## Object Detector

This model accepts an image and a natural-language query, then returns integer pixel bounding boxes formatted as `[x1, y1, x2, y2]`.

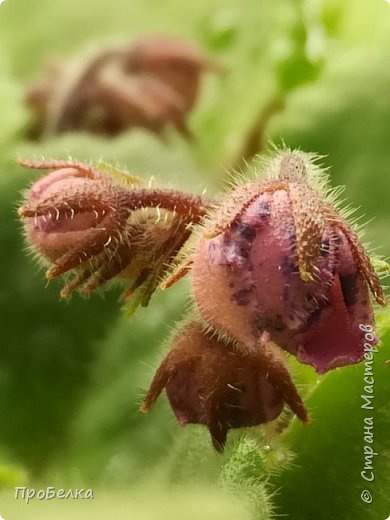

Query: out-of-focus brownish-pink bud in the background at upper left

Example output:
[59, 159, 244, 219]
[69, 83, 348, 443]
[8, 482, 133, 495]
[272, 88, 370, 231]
[26, 36, 217, 137]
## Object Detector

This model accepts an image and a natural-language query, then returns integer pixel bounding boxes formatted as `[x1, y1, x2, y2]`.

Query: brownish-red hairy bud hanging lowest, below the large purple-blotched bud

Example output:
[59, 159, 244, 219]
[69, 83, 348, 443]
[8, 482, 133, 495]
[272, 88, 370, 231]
[141, 321, 307, 451]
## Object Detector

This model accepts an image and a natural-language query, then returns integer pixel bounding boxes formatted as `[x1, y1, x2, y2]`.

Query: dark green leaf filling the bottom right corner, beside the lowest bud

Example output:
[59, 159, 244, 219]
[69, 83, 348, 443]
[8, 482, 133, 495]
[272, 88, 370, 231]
[274, 313, 390, 520]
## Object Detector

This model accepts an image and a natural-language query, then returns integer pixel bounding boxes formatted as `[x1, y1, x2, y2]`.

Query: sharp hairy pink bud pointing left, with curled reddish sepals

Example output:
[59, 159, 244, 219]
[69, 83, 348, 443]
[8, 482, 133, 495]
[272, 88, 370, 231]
[19, 161, 206, 309]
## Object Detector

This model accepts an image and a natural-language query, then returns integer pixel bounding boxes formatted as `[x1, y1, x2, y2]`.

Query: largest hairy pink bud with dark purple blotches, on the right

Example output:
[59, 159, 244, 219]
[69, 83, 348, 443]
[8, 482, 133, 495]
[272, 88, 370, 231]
[192, 151, 385, 372]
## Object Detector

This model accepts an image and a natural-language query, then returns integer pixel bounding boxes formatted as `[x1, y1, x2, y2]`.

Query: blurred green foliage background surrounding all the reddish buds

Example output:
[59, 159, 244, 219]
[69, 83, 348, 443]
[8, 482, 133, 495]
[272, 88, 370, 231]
[0, 0, 390, 520]
